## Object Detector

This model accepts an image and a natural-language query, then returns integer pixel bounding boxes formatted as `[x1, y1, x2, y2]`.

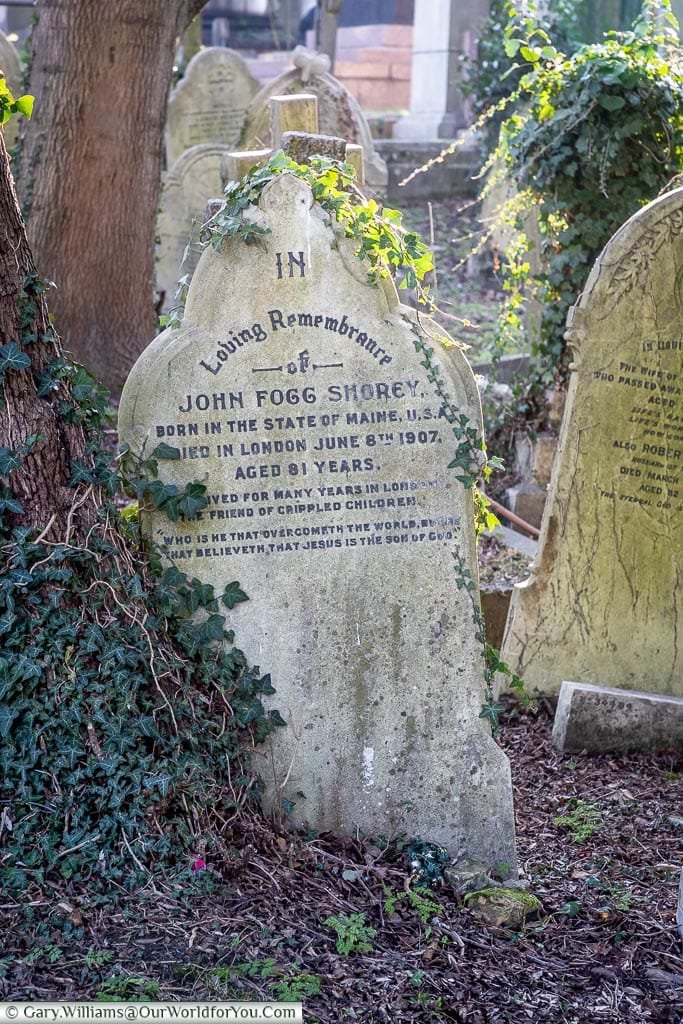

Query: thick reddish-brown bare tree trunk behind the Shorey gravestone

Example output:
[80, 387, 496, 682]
[19, 0, 205, 389]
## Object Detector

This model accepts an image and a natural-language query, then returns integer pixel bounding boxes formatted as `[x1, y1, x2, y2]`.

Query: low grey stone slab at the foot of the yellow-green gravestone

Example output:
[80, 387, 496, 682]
[553, 681, 683, 754]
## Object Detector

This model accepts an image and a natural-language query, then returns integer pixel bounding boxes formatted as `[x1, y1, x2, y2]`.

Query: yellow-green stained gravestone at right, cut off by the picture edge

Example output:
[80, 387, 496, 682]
[503, 189, 683, 695]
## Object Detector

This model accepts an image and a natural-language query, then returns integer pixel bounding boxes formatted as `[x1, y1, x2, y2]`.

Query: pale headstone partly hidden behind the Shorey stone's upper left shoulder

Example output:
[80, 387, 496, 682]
[157, 145, 226, 309]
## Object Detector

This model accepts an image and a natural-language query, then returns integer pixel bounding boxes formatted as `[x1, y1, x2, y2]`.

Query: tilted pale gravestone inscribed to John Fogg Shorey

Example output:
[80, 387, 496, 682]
[120, 167, 515, 870]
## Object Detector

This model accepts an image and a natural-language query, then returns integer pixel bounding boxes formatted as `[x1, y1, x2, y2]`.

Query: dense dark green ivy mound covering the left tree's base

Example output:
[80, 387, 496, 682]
[0, 274, 284, 905]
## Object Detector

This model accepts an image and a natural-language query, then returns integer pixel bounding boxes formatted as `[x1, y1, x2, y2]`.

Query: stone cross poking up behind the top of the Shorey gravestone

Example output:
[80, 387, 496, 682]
[221, 92, 365, 186]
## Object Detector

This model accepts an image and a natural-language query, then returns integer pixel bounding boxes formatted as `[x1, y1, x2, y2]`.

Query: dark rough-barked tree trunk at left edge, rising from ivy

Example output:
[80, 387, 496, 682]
[0, 126, 99, 543]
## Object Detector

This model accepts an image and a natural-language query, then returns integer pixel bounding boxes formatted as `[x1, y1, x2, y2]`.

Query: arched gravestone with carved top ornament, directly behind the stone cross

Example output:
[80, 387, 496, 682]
[240, 68, 388, 191]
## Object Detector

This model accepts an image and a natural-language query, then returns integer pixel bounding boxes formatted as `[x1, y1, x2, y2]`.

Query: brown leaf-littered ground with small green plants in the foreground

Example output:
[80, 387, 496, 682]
[0, 703, 683, 1024]
